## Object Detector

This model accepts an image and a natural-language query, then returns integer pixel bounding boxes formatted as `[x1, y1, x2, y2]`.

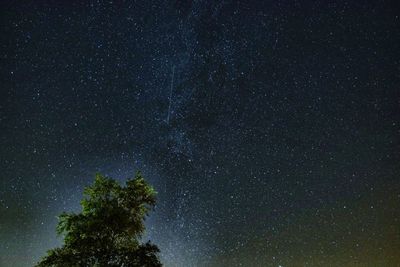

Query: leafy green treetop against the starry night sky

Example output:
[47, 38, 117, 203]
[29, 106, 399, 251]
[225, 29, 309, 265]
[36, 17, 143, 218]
[36, 172, 162, 267]
